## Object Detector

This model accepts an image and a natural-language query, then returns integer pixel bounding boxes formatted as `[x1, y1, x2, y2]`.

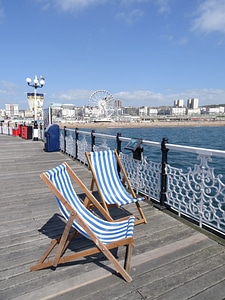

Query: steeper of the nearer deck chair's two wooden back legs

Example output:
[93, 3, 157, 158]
[52, 212, 75, 268]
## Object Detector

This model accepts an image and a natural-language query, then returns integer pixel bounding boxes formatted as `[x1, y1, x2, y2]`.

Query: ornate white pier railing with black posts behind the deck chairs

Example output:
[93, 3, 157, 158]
[60, 128, 225, 234]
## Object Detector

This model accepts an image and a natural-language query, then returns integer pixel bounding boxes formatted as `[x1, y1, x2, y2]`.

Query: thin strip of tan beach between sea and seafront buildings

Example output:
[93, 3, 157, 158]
[59, 120, 225, 128]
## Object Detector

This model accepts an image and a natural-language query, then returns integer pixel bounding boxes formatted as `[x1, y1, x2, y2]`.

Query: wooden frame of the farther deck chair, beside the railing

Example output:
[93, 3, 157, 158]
[85, 150, 147, 225]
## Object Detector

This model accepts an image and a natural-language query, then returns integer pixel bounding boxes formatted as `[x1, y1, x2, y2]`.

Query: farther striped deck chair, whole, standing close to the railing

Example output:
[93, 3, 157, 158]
[85, 150, 147, 225]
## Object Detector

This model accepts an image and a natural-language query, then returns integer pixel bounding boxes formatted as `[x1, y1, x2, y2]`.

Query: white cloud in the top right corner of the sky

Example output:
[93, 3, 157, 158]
[193, 0, 225, 33]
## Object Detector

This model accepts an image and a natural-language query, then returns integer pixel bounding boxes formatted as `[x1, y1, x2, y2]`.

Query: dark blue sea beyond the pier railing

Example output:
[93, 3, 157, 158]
[80, 126, 225, 178]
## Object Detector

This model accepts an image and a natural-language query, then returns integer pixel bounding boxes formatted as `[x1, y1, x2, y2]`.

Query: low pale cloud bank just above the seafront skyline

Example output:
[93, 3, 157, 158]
[0, 81, 225, 109]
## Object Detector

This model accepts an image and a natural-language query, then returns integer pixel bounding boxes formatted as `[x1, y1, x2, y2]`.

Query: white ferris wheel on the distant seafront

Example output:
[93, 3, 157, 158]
[88, 90, 115, 117]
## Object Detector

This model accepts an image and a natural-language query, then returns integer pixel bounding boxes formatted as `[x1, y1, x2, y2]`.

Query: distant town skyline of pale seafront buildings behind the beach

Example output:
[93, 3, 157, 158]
[0, 98, 225, 122]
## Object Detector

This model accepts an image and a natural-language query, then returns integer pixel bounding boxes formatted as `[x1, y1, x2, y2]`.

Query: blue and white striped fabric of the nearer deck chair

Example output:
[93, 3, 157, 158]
[47, 164, 134, 244]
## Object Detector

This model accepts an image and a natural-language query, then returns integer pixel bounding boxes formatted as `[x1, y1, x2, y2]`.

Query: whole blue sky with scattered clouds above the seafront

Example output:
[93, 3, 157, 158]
[0, 0, 225, 109]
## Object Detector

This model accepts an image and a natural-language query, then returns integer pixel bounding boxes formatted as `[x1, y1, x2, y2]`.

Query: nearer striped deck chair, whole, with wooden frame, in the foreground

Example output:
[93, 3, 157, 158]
[31, 163, 134, 282]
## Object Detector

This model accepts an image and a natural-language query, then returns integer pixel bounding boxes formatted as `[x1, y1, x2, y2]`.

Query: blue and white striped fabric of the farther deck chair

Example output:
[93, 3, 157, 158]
[90, 150, 144, 206]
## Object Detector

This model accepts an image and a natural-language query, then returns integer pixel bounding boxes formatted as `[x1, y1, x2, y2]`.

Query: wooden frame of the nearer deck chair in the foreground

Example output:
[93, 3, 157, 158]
[30, 163, 134, 282]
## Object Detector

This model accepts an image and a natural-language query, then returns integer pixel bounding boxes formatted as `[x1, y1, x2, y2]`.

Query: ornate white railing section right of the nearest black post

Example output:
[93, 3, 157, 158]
[166, 144, 225, 232]
